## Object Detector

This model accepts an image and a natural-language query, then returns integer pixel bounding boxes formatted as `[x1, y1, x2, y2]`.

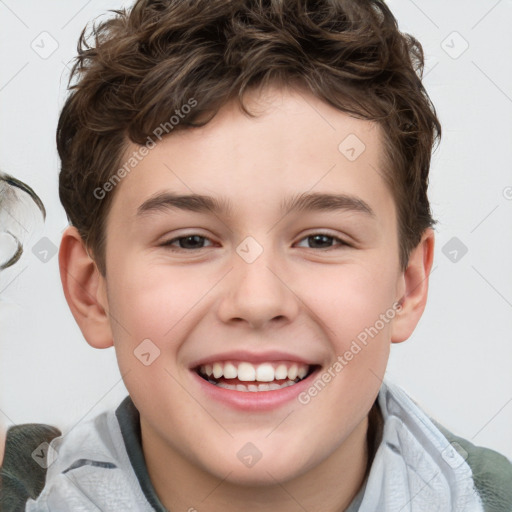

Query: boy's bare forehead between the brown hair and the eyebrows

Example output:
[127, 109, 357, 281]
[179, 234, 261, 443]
[108, 88, 394, 228]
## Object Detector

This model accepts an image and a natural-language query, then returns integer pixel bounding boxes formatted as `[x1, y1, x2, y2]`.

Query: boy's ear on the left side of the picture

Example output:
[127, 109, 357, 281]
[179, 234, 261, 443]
[59, 226, 113, 348]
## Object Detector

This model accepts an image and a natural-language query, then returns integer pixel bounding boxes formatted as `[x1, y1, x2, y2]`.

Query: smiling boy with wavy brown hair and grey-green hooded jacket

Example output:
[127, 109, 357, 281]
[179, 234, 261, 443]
[3, 0, 512, 512]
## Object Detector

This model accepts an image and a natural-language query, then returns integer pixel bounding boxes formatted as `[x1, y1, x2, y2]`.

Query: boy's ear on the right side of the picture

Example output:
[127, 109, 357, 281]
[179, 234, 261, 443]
[391, 228, 434, 343]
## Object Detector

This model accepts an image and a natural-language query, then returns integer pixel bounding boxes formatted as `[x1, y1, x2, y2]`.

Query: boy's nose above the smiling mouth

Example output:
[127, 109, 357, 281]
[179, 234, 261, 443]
[218, 243, 300, 329]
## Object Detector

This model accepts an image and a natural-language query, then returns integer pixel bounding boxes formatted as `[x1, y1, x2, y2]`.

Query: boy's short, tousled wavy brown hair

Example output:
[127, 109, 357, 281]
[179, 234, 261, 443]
[57, 0, 441, 273]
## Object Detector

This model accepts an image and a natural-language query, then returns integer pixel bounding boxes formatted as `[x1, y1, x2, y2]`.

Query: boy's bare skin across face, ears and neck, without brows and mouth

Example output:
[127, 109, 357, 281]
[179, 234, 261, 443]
[60, 85, 434, 511]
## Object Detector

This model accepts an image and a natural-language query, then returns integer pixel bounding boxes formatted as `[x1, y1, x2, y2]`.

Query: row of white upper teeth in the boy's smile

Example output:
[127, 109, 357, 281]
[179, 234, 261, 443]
[200, 362, 309, 382]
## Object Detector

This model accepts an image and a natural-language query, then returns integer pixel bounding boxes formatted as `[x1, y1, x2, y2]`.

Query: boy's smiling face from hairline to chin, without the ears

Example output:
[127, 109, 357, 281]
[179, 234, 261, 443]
[99, 89, 403, 484]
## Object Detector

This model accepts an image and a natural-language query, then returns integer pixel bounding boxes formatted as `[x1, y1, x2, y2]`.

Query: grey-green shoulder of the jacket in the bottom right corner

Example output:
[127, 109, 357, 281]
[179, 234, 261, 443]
[434, 422, 512, 512]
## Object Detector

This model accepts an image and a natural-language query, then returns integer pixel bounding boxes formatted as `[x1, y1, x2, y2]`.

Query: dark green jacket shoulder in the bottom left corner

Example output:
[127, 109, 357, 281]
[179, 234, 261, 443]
[0, 423, 61, 512]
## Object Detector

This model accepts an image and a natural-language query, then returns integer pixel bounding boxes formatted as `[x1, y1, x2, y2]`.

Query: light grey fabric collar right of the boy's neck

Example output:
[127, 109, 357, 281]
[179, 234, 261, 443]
[352, 382, 483, 512]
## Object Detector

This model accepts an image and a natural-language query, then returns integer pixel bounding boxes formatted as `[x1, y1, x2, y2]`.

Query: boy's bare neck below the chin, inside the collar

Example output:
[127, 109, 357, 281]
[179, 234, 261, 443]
[141, 417, 372, 512]
